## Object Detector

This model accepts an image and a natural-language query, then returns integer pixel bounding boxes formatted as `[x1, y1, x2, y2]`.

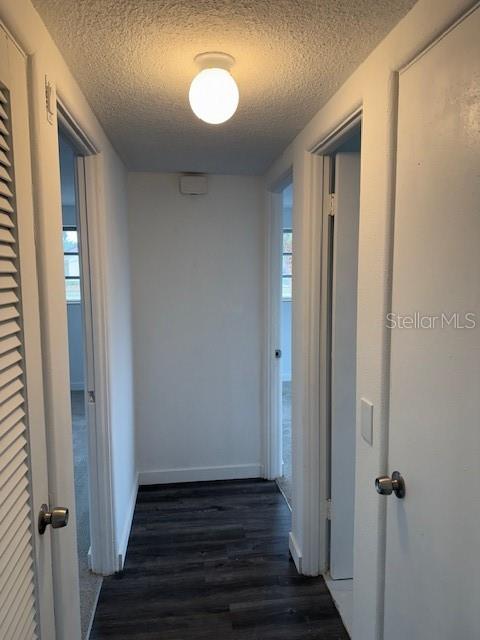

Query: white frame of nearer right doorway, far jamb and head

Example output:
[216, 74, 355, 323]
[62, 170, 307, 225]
[310, 106, 362, 574]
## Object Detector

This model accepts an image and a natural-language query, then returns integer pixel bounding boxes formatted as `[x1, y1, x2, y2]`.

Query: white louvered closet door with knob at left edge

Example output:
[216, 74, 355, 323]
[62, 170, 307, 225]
[0, 28, 54, 640]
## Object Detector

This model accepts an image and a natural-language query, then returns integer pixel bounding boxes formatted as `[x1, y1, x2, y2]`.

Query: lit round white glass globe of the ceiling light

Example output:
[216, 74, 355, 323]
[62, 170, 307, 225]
[188, 68, 240, 124]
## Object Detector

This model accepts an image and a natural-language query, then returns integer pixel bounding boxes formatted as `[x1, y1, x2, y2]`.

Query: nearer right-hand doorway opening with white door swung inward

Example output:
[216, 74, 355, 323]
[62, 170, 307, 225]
[325, 127, 361, 632]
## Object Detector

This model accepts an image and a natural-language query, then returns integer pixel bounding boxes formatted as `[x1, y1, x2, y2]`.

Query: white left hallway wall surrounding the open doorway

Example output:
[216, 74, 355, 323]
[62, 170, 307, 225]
[0, 0, 136, 620]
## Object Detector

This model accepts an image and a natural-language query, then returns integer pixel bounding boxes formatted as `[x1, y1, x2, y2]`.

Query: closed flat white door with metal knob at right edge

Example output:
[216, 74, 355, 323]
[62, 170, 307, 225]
[380, 10, 480, 640]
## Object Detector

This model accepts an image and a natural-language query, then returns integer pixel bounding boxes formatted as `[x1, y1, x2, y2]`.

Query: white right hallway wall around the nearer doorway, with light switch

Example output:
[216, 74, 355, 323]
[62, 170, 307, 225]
[265, 0, 474, 640]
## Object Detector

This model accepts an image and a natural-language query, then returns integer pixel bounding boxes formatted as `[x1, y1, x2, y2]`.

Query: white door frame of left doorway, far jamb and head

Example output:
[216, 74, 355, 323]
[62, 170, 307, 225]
[57, 101, 119, 575]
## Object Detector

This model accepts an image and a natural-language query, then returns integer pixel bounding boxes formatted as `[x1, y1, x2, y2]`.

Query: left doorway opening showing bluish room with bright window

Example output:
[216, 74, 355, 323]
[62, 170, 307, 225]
[59, 129, 102, 638]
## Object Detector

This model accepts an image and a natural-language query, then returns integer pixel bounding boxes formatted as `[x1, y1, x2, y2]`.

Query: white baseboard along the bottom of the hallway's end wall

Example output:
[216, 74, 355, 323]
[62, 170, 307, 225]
[138, 464, 263, 485]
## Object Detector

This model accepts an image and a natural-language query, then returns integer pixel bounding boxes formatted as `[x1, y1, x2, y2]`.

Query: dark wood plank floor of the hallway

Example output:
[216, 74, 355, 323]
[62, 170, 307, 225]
[90, 480, 348, 640]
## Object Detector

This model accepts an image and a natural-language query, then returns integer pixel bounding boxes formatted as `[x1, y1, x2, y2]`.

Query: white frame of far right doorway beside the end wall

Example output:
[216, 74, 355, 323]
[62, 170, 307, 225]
[264, 167, 293, 480]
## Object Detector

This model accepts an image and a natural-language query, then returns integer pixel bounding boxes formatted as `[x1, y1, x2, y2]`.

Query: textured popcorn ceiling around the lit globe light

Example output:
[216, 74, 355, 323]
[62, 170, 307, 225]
[33, 0, 415, 174]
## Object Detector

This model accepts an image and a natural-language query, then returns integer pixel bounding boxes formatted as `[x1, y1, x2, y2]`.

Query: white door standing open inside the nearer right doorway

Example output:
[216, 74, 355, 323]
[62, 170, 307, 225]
[330, 153, 360, 579]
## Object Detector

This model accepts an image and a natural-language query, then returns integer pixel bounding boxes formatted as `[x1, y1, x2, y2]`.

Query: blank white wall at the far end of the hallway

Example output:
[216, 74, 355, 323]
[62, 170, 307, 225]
[128, 173, 264, 483]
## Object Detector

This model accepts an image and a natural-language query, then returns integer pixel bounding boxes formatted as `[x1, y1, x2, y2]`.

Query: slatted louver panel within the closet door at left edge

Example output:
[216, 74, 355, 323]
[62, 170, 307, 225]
[0, 77, 37, 640]
